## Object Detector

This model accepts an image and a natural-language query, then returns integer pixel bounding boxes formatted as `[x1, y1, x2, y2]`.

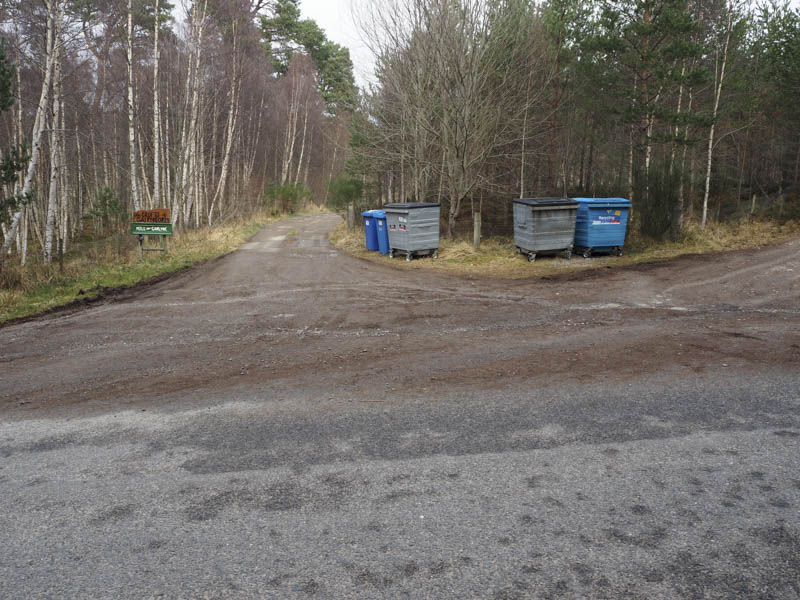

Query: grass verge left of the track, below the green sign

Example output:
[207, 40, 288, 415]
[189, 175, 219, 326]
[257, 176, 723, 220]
[0, 214, 281, 324]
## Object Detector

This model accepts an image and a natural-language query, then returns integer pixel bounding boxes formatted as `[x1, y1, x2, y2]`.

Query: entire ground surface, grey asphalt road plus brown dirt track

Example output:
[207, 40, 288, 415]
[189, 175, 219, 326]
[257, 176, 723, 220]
[0, 214, 800, 599]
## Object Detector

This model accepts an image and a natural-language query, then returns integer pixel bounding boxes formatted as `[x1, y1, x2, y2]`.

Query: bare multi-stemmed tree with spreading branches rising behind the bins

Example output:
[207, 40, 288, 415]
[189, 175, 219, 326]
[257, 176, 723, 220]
[363, 0, 553, 236]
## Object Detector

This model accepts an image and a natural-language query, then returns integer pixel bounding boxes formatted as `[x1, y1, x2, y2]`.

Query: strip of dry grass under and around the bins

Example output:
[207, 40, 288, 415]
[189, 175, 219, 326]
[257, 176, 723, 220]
[330, 221, 800, 279]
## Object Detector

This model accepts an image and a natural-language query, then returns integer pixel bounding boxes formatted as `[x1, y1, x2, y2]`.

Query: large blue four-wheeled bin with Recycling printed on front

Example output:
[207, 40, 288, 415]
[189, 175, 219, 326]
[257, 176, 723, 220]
[573, 198, 631, 258]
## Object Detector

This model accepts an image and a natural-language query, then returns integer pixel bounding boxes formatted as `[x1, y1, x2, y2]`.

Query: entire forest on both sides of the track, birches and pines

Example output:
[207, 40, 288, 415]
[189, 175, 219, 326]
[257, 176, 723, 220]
[0, 0, 800, 266]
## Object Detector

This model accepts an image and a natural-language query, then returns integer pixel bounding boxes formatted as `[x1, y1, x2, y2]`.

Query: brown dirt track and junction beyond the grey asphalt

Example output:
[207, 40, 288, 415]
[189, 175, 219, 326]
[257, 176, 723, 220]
[0, 215, 800, 417]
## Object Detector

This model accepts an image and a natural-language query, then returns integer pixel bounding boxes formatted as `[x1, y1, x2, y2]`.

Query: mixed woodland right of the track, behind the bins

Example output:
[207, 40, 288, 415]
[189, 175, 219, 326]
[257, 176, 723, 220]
[352, 0, 800, 239]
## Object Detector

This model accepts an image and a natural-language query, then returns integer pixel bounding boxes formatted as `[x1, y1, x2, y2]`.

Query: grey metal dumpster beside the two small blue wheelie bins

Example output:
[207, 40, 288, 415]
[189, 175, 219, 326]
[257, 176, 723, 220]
[383, 202, 441, 260]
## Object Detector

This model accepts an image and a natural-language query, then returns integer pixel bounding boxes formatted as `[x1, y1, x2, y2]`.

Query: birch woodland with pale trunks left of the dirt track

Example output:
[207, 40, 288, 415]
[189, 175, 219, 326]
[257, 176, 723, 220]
[0, 0, 357, 264]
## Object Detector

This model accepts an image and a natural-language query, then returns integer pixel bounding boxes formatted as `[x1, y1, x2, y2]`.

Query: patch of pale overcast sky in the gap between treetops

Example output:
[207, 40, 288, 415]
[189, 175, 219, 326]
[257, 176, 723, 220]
[300, 0, 373, 87]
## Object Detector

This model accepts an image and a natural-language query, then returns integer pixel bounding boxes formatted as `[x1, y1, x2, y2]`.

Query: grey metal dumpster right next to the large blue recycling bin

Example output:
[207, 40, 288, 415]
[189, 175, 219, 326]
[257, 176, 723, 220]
[514, 198, 578, 262]
